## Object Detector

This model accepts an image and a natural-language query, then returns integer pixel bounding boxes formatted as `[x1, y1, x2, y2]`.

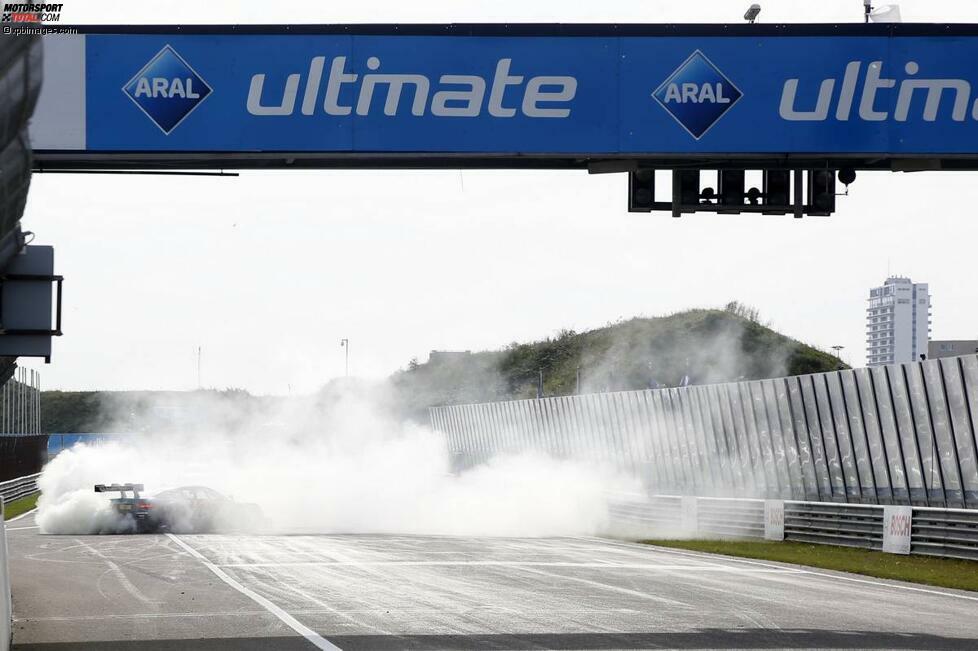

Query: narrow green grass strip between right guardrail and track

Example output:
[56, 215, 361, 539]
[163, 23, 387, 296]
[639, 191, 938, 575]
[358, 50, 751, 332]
[642, 540, 978, 592]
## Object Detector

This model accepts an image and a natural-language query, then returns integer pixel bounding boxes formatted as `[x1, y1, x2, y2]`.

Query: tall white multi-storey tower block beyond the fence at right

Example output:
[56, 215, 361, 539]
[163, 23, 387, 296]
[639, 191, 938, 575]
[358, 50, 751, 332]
[866, 276, 930, 366]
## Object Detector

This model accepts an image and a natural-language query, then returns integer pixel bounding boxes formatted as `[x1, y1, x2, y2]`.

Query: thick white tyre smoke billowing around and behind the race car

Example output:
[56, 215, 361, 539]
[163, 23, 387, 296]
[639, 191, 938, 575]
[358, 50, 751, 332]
[38, 384, 637, 536]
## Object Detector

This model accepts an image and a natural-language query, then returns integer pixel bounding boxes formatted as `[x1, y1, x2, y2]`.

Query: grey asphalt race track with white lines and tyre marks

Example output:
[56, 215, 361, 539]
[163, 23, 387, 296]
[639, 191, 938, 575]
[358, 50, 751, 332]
[8, 516, 978, 651]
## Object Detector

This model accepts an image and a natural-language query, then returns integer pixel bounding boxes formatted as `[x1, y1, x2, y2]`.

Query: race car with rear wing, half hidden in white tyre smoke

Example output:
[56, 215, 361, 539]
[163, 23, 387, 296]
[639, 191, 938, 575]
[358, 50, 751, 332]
[95, 484, 265, 533]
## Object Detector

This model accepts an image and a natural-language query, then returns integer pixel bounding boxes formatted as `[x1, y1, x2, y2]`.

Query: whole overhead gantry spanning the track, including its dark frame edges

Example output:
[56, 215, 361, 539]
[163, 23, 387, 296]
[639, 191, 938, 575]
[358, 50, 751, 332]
[32, 23, 978, 172]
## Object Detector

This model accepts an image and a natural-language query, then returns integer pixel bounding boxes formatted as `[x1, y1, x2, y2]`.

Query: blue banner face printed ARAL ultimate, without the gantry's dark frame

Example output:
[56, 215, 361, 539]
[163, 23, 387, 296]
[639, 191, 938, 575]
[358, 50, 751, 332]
[30, 33, 978, 155]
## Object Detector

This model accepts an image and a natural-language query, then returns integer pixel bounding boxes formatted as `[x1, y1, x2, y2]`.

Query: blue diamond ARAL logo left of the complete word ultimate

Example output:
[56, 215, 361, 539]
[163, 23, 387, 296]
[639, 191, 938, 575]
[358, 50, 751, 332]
[122, 45, 212, 135]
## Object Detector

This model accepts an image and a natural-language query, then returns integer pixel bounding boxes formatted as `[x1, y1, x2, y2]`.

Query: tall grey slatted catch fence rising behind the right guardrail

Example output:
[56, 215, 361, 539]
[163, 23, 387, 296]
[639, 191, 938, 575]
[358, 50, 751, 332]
[430, 355, 978, 508]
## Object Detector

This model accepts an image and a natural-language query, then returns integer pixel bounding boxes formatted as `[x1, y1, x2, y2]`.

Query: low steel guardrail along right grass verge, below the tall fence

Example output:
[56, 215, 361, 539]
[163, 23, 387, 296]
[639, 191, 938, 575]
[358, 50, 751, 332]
[609, 495, 978, 560]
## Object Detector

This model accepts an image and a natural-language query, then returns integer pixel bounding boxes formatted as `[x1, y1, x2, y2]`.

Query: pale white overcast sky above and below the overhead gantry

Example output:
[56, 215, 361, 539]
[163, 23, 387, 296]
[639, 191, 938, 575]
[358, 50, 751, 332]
[24, 0, 978, 393]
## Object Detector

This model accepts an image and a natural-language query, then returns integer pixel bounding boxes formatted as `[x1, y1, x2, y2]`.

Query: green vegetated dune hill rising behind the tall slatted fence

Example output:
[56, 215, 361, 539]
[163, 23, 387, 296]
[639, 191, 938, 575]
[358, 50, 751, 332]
[393, 303, 840, 418]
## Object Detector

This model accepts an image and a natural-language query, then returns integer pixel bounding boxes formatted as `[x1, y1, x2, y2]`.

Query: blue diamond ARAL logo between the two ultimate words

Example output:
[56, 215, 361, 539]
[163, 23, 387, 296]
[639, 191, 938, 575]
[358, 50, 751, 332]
[652, 50, 743, 140]
